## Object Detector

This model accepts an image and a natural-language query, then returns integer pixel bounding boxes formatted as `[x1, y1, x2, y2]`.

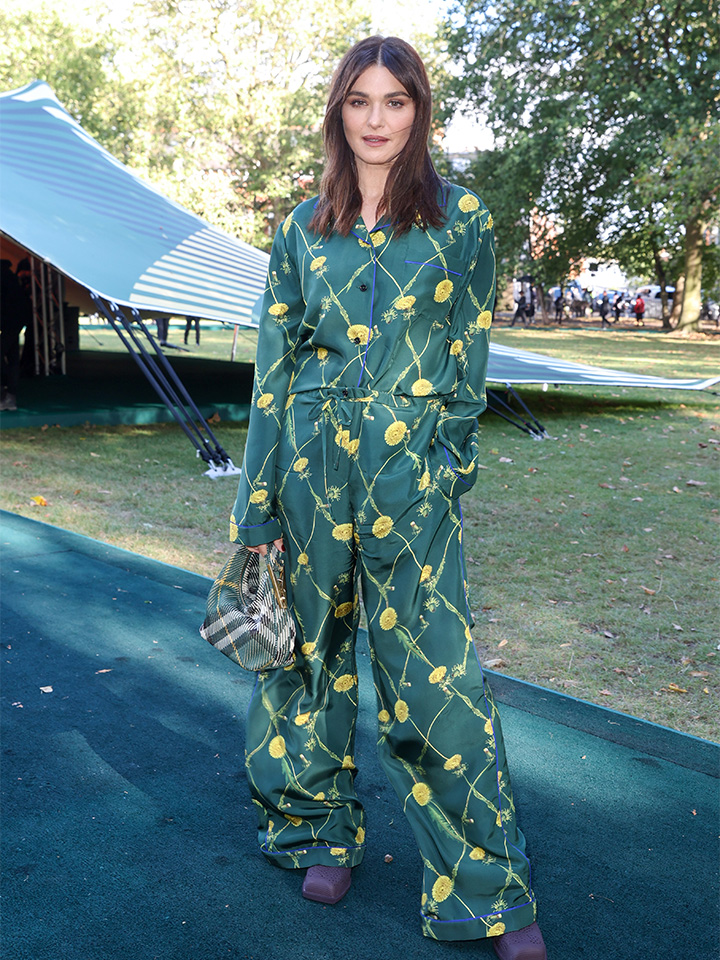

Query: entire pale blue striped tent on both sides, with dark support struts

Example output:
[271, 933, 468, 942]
[0, 82, 720, 450]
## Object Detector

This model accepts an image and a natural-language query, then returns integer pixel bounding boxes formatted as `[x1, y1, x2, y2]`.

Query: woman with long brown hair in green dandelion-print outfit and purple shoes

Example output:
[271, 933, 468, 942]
[231, 37, 545, 960]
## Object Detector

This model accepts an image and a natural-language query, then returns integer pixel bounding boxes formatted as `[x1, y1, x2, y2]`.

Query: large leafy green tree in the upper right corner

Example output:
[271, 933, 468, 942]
[445, 0, 720, 323]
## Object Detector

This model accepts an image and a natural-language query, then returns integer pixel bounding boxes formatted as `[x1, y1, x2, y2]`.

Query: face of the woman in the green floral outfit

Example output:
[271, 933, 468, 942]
[342, 65, 415, 172]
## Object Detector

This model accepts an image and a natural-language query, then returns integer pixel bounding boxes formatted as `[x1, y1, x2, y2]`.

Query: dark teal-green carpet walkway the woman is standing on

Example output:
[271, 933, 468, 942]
[0, 513, 718, 960]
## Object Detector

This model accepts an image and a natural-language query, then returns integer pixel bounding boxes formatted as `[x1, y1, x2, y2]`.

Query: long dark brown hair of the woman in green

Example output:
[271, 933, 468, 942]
[309, 36, 445, 236]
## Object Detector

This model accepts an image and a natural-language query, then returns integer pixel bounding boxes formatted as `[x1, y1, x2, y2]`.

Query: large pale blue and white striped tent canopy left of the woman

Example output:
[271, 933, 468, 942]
[0, 82, 268, 325]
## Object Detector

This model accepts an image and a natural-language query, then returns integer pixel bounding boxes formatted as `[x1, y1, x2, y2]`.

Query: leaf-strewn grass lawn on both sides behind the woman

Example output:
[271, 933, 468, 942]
[0, 325, 720, 740]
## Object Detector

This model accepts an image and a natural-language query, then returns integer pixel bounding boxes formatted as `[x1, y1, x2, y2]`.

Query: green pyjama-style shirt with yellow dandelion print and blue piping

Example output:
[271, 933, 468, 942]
[230, 185, 495, 546]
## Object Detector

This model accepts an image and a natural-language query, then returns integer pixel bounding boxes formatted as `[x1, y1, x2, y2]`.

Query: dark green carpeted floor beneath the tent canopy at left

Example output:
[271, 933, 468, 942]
[0, 350, 254, 429]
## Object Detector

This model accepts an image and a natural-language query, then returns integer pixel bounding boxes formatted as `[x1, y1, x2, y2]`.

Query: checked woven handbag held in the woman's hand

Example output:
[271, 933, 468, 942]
[200, 546, 296, 671]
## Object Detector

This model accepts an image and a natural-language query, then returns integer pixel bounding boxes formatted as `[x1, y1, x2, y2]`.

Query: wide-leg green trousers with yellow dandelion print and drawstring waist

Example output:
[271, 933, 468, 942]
[246, 390, 535, 940]
